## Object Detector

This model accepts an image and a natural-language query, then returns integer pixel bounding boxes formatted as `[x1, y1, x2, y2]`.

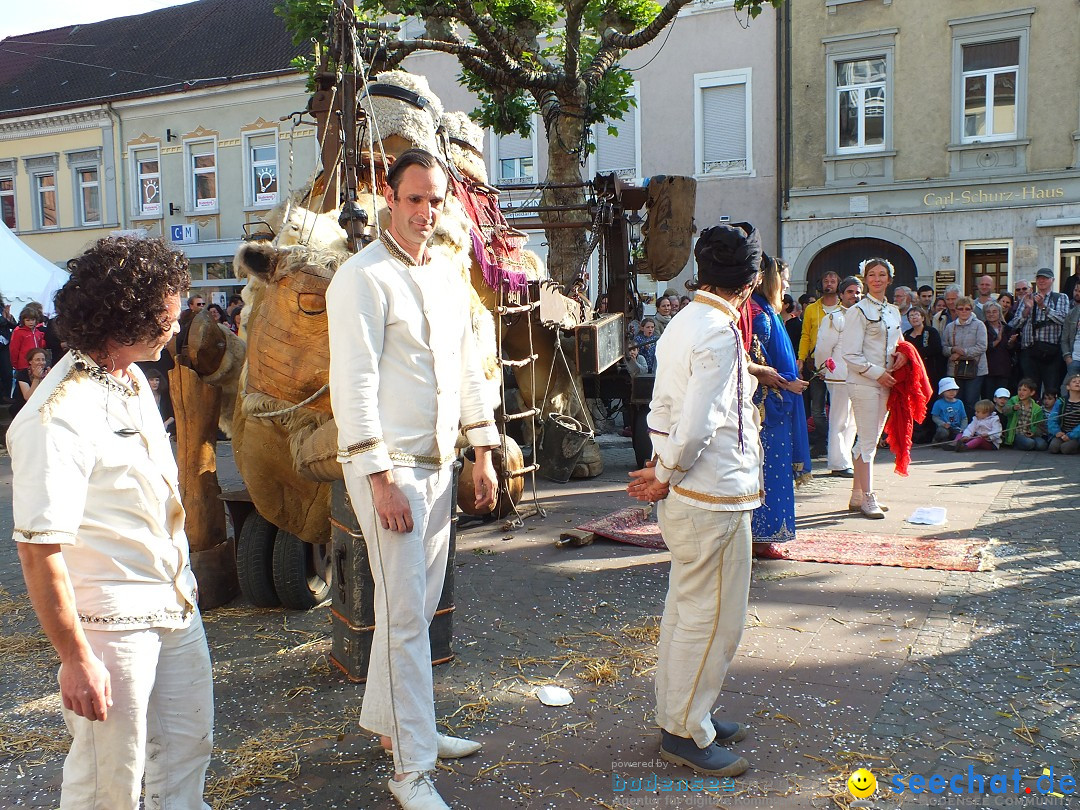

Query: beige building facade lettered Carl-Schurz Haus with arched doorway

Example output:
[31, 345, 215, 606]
[781, 0, 1080, 293]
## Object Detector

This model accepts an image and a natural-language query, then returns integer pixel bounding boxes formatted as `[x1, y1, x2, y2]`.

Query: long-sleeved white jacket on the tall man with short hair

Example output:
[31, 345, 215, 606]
[326, 232, 499, 475]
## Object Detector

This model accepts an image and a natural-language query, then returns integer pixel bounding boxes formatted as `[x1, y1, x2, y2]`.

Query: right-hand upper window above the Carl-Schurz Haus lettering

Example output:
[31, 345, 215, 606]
[962, 39, 1020, 144]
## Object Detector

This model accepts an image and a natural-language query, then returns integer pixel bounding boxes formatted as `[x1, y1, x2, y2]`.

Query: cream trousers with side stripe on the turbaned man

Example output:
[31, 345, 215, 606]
[657, 498, 753, 748]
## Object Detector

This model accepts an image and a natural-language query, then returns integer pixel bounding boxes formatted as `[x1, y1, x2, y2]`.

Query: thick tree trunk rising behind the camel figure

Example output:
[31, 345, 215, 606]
[542, 96, 589, 287]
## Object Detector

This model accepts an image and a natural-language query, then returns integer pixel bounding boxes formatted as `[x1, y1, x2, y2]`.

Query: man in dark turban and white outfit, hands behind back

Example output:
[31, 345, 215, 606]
[627, 222, 764, 777]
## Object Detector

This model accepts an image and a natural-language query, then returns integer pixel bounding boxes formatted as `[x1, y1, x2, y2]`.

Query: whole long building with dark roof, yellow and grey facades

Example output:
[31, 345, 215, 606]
[0, 0, 315, 301]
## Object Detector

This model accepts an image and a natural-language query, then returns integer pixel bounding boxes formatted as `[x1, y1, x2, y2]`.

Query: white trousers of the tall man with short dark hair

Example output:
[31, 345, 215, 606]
[345, 464, 454, 773]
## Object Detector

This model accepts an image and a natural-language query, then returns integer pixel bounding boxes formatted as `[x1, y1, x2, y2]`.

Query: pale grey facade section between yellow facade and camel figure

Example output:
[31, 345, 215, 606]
[114, 73, 315, 303]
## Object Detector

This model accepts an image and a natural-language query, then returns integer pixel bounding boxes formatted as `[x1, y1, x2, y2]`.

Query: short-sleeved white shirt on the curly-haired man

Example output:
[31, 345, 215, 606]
[8, 352, 197, 630]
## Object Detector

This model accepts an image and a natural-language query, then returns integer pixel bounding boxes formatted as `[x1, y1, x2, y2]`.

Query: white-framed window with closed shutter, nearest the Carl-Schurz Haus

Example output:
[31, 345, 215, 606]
[693, 68, 754, 177]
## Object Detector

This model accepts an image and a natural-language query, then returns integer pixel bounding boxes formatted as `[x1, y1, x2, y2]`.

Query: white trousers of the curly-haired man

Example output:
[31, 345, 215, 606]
[60, 613, 214, 810]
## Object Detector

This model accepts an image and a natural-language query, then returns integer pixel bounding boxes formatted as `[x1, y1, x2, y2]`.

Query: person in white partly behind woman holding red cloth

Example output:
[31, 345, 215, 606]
[813, 275, 863, 478]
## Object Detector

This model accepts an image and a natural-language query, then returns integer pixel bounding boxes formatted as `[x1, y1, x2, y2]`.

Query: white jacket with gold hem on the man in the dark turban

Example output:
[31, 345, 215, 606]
[648, 289, 765, 512]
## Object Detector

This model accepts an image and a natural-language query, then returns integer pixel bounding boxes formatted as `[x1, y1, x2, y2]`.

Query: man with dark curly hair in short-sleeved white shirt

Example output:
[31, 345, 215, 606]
[8, 238, 214, 810]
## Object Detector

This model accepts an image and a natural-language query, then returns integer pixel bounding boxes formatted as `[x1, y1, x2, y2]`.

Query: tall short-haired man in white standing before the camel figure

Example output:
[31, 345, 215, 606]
[326, 149, 499, 810]
